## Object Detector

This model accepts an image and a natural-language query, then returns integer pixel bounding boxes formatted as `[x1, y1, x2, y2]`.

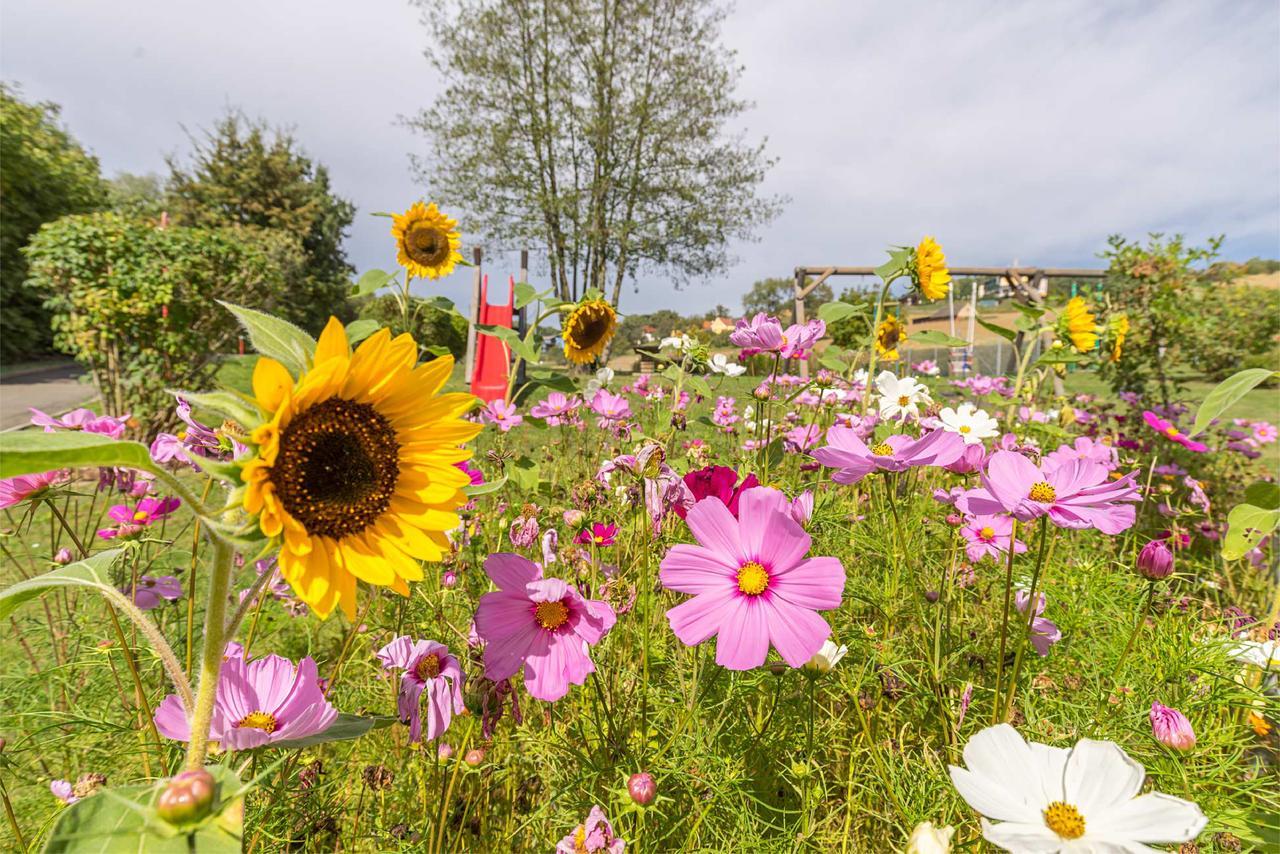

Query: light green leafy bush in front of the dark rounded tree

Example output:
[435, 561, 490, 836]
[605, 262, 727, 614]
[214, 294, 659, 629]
[26, 214, 301, 435]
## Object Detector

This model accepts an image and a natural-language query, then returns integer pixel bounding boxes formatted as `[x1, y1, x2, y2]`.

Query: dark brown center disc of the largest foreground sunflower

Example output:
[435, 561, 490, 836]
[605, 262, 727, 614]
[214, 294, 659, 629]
[271, 397, 399, 539]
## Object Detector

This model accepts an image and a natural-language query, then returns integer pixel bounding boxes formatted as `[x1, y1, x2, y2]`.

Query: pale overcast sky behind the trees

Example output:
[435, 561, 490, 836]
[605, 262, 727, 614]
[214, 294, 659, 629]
[0, 0, 1280, 312]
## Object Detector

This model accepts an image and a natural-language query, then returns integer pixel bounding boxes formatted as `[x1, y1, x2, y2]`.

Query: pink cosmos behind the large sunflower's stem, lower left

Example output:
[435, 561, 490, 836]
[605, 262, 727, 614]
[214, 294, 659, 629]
[155, 644, 338, 750]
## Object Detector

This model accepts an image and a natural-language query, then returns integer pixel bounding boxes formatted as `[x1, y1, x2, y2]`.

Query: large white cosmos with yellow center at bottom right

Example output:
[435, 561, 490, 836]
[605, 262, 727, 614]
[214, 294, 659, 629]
[951, 723, 1208, 854]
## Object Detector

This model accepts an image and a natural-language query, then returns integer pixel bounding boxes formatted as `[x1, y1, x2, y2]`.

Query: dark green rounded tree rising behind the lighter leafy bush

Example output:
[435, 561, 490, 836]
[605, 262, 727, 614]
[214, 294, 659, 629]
[168, 111, 356, 332]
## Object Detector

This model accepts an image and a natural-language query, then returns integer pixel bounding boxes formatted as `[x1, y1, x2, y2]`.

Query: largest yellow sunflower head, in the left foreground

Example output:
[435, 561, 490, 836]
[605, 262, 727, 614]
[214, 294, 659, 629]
[241, 318, 480, 617]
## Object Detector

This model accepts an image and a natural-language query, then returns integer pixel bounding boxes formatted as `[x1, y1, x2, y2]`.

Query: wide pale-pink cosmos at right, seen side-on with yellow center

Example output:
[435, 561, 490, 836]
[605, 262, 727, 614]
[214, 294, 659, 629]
[956, 451, 1140, 534]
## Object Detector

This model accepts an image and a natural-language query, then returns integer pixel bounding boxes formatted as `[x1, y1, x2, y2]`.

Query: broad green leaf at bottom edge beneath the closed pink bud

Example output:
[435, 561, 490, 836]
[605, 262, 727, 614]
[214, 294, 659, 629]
[45, 766, 244, 854]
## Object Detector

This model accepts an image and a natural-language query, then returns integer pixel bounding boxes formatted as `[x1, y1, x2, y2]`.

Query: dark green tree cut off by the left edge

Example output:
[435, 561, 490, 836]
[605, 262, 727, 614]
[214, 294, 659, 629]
[0, 83, 106, 361]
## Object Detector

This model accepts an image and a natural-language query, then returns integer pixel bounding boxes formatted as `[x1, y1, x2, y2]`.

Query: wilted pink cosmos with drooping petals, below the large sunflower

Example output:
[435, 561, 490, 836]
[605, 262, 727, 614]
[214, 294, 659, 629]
[378, 635, 466, 744]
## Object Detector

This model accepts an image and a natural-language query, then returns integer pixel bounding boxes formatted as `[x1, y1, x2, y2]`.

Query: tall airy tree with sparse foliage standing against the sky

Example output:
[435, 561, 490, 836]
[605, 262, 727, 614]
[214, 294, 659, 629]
[408, 0, 780, 311]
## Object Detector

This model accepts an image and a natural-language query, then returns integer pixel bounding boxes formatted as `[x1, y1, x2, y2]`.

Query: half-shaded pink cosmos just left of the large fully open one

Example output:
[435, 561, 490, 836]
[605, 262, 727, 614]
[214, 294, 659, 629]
[475, 552, 617, 702]
